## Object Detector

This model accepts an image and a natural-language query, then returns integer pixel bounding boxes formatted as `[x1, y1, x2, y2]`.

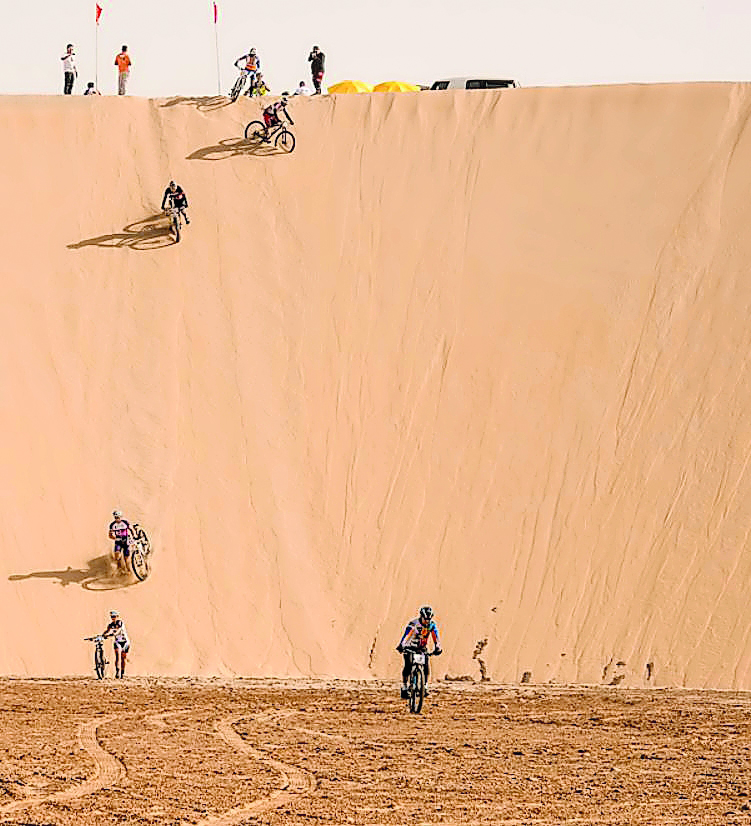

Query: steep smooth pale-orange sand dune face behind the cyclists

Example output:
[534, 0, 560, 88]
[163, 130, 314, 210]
[0, 85, 751, 688]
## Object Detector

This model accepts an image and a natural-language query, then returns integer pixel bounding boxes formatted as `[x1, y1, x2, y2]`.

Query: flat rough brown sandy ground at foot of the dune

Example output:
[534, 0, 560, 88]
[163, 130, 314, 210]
[0, 678, 751, 826]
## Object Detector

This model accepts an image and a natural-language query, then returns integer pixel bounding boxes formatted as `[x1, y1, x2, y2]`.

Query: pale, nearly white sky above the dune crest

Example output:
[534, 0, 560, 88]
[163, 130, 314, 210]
[0, 0, 751, 96]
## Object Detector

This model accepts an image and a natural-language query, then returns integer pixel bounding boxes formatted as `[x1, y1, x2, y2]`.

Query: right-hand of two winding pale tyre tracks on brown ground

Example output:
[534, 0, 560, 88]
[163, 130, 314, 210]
[196, 711, 316, 826]
